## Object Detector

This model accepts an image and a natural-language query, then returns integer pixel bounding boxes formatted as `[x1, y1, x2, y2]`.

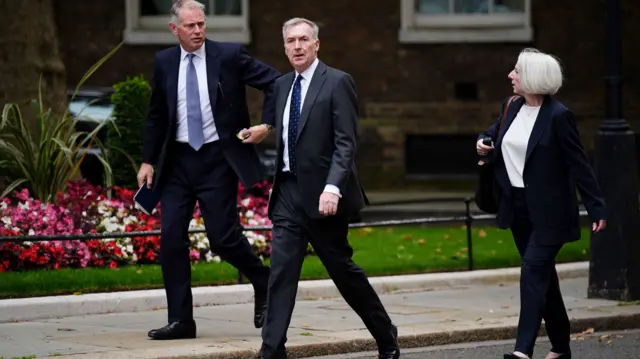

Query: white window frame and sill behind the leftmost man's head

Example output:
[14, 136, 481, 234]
[123, 0, 251, 45]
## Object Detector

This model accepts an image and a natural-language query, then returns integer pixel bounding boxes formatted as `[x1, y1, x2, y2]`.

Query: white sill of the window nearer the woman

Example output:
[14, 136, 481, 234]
[398, 27, 533, 44]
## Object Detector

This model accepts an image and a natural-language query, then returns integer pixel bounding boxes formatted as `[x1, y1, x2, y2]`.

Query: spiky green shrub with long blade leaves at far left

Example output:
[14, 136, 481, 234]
[0, 43, 122, 202]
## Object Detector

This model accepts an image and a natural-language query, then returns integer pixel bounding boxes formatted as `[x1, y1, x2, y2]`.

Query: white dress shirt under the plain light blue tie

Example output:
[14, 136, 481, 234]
[176, 44, 219, 143]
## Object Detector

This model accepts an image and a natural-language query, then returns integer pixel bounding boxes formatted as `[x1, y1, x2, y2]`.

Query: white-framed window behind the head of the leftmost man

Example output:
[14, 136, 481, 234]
[124, 0, 251, 45]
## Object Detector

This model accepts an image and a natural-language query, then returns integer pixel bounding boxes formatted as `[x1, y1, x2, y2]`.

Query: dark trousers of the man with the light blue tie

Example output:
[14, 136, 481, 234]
[160, 141, 269, 323]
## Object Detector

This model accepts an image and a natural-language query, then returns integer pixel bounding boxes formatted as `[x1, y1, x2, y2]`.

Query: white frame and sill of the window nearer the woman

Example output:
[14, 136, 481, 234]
[398, 0, 533, 44]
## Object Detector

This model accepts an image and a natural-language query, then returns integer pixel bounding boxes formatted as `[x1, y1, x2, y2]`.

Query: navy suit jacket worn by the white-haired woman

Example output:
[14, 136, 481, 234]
[478, 96, 607, 244]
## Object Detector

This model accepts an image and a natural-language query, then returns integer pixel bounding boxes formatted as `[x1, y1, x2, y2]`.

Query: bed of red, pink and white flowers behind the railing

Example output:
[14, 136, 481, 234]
[0, 181, 271, 272]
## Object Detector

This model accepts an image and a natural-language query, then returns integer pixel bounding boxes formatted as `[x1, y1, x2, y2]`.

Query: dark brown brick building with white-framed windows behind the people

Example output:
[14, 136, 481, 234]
[55, 0, 640, 188]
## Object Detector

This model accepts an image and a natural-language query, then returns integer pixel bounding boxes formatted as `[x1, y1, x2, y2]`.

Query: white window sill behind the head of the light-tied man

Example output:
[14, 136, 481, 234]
[123, 28, 251, 45]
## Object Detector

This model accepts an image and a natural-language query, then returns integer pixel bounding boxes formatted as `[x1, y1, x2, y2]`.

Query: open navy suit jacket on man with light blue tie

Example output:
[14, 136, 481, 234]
[142, 40, 280, 190]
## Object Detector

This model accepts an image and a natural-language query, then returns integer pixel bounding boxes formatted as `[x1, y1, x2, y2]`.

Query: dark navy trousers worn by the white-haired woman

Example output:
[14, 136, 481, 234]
[511, 188, 571, 357]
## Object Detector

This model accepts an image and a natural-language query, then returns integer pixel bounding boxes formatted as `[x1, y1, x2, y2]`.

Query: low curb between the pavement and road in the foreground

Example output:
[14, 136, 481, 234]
[39, 313, 640, 359]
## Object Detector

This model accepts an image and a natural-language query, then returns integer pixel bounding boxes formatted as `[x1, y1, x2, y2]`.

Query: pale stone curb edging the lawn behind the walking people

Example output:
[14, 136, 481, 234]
[0, 262, 589, 323]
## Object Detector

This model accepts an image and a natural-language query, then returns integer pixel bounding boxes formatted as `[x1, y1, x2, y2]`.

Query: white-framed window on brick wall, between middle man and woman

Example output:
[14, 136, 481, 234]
[399, 0, 533, 43]
